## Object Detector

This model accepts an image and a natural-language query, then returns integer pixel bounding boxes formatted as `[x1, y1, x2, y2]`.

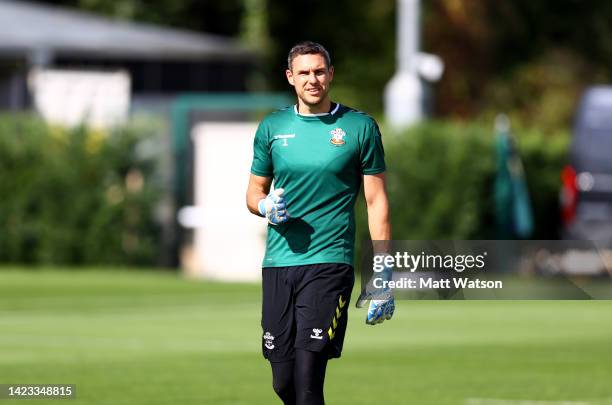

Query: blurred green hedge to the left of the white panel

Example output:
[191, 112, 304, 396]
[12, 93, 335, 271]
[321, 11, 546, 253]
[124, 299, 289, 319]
[0, 115, 160, 264]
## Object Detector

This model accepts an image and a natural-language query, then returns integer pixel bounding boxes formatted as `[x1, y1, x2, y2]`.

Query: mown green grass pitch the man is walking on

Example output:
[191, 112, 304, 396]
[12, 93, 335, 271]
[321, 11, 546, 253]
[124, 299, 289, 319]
[0, 268, 612, 405]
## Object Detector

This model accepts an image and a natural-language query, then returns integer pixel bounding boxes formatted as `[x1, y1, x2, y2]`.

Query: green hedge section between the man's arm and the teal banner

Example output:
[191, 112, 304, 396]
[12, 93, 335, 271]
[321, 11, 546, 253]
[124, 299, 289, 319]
[386, 122, 495, 239]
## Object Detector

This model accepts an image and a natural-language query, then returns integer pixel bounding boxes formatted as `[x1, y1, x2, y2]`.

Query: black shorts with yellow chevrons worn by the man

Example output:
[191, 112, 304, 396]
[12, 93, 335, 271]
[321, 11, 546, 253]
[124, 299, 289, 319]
[261, 263, 355, 362]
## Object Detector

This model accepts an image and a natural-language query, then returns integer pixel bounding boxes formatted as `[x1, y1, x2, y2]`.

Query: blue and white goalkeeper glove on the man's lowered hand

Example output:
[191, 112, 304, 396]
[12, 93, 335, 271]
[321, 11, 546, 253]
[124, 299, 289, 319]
[356, 256, 395, 325]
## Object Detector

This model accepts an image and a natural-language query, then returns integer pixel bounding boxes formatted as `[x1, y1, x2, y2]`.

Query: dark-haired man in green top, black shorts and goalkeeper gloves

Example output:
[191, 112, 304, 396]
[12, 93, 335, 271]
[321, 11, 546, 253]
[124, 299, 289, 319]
[247, 42, 394, 405]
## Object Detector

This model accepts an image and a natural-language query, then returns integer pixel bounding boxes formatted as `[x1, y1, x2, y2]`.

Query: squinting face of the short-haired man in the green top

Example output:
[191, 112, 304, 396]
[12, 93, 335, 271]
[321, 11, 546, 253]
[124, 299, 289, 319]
[285, 54, 334, 106]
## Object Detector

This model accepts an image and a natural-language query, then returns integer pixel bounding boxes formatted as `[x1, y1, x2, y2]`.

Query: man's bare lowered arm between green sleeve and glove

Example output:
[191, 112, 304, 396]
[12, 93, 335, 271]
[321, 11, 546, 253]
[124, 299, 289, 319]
[363, 173, 391, 253]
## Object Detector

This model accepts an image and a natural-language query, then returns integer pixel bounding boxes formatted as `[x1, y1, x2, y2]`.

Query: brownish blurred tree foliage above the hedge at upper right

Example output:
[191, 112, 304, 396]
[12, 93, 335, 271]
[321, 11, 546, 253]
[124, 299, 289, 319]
[423, 0, 612, 126]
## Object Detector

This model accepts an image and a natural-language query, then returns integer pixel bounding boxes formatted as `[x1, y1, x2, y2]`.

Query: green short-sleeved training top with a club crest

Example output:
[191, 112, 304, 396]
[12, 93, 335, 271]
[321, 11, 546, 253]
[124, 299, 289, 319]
[251, 104, 385, 267]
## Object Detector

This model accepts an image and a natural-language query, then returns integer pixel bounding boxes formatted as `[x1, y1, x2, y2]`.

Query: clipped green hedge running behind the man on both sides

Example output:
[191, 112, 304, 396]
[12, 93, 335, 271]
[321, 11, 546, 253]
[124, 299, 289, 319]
[0, 115, 569, 265]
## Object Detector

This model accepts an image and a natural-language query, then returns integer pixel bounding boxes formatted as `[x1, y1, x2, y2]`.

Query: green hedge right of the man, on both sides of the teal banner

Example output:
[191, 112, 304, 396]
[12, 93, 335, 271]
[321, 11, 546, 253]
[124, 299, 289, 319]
[357, 122, 569, 240]
